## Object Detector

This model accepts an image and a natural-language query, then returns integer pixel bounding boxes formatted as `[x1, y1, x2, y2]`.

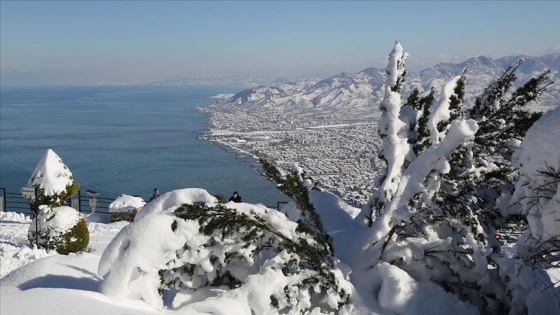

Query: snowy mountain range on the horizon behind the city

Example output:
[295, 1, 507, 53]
[223, 54, 560, 109]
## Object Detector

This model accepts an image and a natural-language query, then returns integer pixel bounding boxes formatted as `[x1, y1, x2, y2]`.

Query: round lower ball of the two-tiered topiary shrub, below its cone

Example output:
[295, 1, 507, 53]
[27, 205, 89, 255]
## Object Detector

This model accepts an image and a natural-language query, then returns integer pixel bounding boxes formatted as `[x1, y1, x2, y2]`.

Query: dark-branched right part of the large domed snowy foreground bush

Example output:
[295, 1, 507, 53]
[162, 203, 352, 314]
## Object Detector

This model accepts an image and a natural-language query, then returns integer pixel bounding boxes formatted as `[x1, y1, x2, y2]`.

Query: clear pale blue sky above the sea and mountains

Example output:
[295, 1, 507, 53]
[0, 0, 560, 83]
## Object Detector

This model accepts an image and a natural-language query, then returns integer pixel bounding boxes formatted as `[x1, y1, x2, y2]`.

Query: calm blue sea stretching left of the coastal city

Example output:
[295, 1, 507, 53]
[0, 86, 288, 205]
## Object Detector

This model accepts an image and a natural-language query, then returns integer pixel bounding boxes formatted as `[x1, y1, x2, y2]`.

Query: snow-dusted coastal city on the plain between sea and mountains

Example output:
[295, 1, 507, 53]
[202, 102, 383, 207]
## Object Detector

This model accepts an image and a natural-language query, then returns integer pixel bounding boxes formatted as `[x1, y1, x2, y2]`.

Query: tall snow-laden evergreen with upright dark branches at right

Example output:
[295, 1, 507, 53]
[356, 43, 549, 313]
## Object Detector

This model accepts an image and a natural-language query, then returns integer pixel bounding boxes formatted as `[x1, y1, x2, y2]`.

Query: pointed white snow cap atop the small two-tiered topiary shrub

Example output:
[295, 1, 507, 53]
[27, 149, 73, 196]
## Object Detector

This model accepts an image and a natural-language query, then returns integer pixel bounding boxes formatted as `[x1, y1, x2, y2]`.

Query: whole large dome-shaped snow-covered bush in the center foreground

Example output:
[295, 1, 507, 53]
[99, 189, 353, 314]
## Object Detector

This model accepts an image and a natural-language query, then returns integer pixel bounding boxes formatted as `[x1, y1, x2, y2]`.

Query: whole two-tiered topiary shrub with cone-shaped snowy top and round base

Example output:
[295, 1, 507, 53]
[26, 149, 89, 254]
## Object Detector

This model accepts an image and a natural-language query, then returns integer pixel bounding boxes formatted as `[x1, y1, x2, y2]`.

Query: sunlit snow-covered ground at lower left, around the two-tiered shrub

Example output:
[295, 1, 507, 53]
[0, 212, 147, 315]
